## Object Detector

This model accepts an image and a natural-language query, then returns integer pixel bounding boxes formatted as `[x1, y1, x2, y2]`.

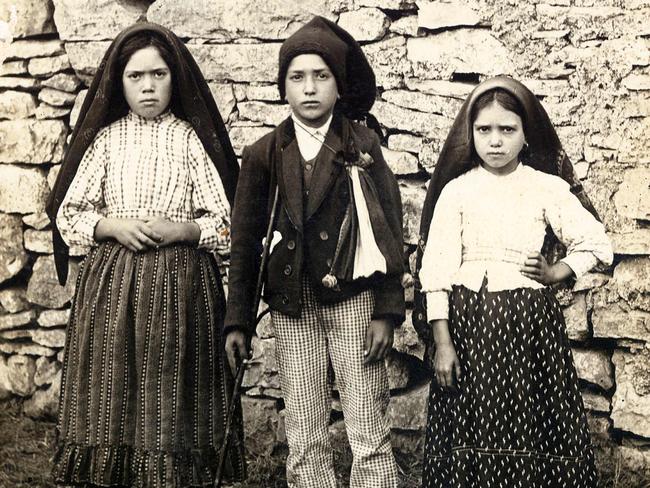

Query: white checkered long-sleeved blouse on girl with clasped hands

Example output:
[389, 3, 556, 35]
[57, 111, 230, 253]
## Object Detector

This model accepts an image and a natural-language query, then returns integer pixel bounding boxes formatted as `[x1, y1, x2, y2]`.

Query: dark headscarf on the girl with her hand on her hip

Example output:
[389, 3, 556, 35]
[413, 76, 598, 341]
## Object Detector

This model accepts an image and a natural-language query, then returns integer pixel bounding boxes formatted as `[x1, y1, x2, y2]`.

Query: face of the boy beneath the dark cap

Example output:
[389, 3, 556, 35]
[284, 54, 339, 127]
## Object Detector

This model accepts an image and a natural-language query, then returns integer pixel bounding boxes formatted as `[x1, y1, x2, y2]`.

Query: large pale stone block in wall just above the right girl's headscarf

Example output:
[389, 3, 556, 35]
[406, 29, 515, 79]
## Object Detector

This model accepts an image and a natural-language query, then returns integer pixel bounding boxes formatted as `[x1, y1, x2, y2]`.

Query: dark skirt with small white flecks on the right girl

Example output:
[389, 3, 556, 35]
[423, 283, 596, 488]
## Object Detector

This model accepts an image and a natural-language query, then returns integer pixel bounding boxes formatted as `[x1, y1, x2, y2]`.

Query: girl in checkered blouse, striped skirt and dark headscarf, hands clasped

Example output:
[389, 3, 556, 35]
[48, 24, 244, 488]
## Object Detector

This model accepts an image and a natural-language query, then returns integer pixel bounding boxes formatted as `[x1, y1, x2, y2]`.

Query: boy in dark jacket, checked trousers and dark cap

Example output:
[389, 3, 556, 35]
[224, 17, 404, 488]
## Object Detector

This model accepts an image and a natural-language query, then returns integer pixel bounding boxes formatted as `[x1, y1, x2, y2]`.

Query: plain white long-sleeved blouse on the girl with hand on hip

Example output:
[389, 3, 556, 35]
[420, 164, 613, 321]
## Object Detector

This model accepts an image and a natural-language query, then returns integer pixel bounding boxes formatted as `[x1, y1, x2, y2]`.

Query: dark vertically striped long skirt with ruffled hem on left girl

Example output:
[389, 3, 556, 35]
[53, 242, 245, 488]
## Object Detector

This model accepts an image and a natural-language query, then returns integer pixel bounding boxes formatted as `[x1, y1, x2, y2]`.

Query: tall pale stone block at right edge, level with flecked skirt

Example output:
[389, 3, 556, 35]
[612, 349, 650, 437]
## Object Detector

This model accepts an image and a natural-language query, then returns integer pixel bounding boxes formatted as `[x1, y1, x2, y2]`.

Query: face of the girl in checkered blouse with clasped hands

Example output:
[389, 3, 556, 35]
[122, 46, 172, 119]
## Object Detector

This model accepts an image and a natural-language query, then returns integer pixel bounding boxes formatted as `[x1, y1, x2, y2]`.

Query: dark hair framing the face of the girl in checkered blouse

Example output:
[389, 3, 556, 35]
[113, 31, 185, 118]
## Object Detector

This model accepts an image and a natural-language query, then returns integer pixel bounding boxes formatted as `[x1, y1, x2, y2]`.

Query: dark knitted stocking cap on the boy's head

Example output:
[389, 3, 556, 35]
[278, 16, 377, 129]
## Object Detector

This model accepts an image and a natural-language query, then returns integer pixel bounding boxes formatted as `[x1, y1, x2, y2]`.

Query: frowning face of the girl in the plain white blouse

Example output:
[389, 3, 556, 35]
[472, 101, 526, 174]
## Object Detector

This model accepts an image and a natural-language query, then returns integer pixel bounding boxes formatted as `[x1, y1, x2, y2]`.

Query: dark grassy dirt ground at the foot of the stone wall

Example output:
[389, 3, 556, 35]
[0, 402, 650, 488]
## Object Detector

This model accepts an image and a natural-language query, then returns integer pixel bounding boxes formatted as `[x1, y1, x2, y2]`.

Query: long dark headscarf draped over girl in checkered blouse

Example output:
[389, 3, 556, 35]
[47, 23, 239, 284]
